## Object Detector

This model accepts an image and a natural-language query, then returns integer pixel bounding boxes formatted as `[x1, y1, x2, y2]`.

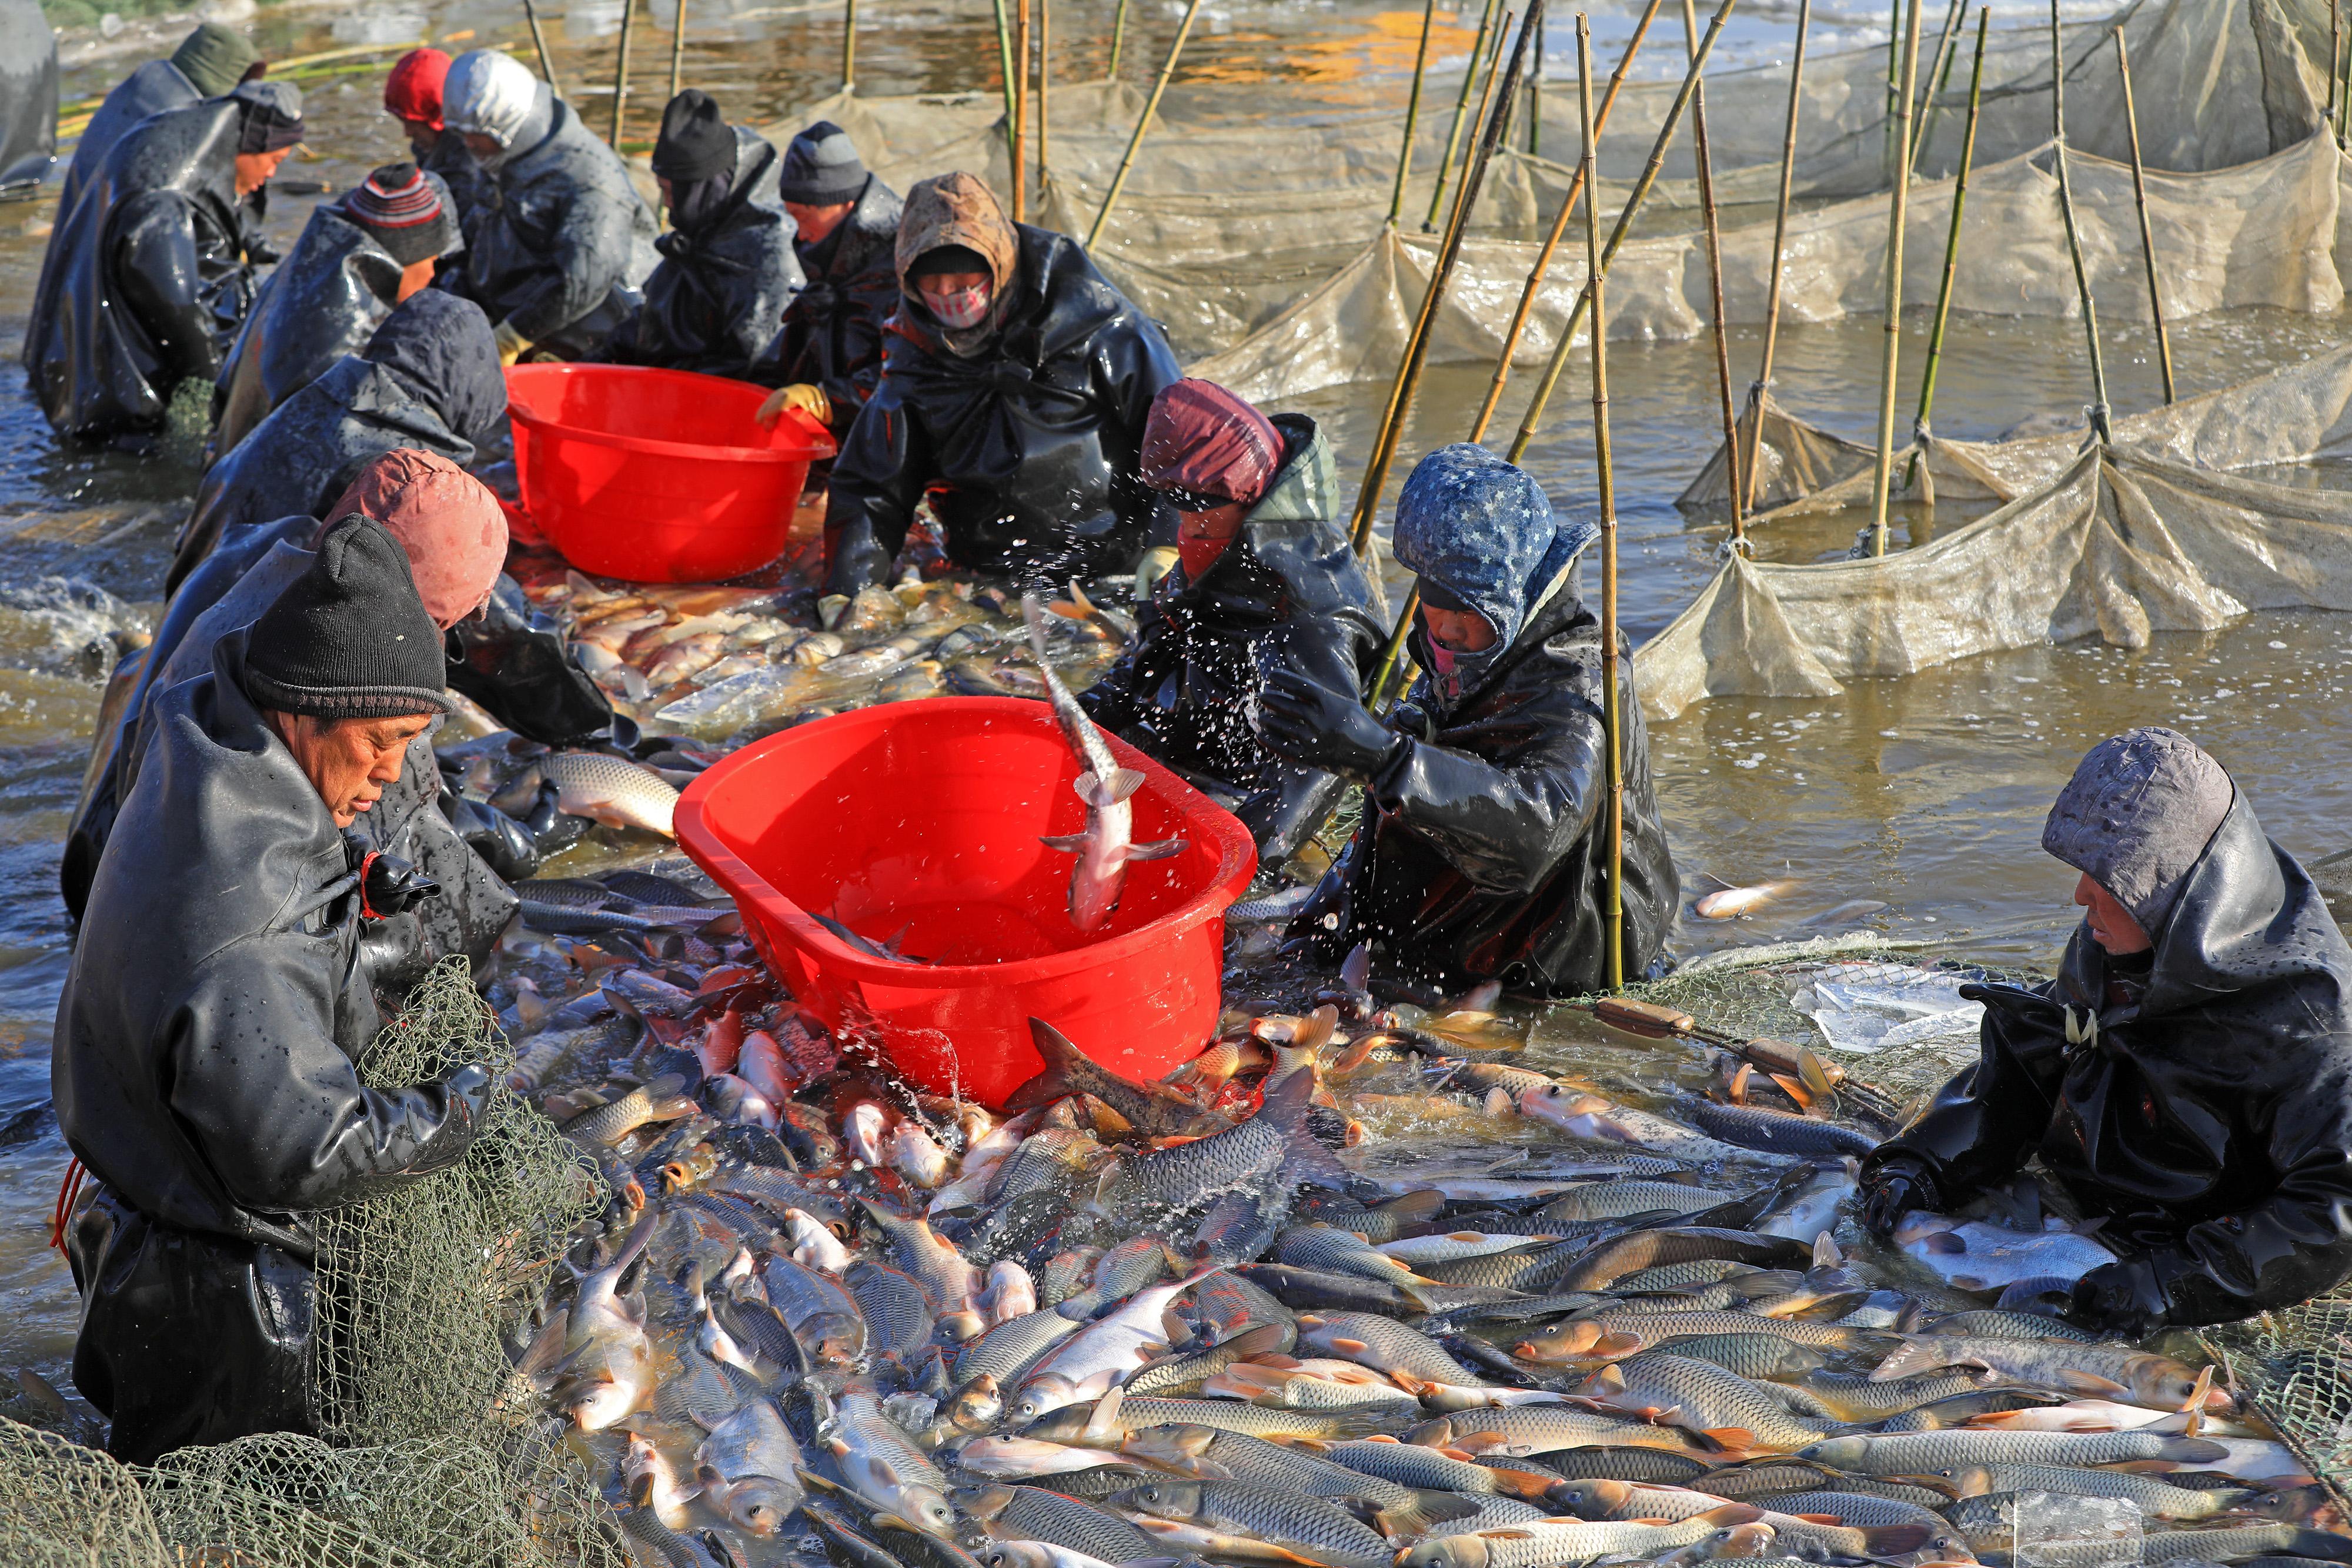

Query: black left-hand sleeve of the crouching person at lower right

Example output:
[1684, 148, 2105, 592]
[1863, 985, 2065, 1208]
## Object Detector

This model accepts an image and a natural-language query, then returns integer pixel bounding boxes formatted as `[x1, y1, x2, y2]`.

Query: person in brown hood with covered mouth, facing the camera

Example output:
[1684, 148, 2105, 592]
[826, 174, 1178, 595]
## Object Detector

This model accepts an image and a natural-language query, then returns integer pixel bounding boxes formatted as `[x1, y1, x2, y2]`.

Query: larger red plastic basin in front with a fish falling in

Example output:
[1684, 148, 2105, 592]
[677, 696, 1258, 1105]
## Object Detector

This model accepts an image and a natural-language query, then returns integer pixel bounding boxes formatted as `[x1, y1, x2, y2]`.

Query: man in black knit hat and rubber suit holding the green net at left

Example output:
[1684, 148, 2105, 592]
[49, 517, 489, 1462]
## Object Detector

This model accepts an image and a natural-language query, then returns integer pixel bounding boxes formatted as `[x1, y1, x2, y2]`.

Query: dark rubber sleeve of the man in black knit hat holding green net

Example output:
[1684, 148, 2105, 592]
[165, 931, 487, 1213]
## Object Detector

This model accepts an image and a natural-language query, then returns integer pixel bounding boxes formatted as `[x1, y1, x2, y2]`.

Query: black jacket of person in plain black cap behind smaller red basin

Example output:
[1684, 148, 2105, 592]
[600, 125, 804, 379]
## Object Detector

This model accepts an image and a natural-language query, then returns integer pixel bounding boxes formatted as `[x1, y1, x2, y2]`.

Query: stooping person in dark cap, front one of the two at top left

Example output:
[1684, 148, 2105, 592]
[24, 82, 303, 442]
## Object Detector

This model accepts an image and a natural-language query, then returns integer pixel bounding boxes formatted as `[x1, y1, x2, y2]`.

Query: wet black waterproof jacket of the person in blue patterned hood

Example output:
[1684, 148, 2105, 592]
[1291, 583, 1682, 997]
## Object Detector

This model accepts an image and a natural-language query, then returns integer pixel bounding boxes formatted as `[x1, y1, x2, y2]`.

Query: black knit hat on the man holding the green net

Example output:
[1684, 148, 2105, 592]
[245, 515, 449, 720]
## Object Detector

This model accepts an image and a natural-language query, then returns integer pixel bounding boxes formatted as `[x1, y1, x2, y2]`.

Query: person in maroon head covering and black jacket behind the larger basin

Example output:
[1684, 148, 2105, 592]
[1080, 381, 1383, 865]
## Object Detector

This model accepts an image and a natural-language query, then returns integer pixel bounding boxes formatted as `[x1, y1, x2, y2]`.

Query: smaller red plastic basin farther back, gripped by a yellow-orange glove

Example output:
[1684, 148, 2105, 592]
[506, 365, 833, 583]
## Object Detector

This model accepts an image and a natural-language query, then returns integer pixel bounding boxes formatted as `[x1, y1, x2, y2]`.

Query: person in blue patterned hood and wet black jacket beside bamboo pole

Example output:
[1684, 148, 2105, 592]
[1256, 444, 1682, 997]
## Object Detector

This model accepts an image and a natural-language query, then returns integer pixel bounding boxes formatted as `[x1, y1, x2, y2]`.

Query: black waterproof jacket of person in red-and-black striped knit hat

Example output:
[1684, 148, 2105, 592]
[212, 202, 400, 461]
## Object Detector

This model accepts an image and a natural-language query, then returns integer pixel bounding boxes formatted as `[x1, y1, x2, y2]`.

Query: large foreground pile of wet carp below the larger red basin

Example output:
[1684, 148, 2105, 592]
[492, 893, 2352, 1568]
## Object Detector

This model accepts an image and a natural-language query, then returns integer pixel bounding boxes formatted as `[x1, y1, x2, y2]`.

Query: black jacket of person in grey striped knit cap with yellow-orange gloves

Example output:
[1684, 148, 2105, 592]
[750, 174, 906, 440]
